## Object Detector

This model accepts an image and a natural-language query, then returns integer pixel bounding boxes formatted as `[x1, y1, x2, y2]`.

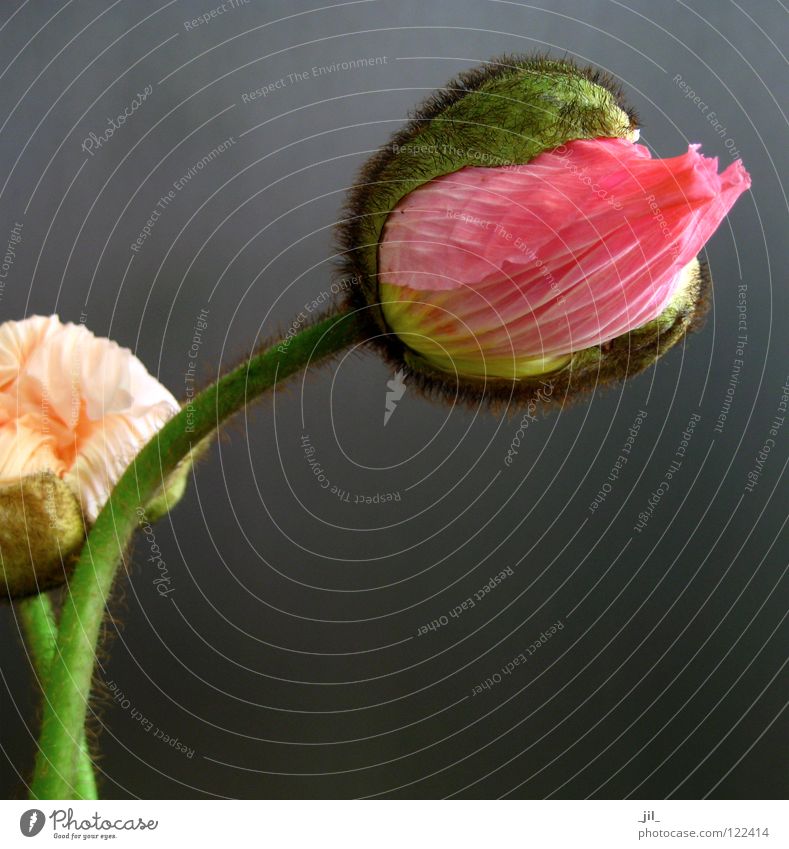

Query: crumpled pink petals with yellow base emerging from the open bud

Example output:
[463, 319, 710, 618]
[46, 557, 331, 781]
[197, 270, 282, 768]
[379, 138, 750, 366]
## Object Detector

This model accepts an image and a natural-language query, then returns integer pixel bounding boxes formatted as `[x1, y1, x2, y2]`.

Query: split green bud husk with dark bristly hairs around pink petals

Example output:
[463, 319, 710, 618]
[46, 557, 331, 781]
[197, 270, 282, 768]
[330, 55, 728, 409]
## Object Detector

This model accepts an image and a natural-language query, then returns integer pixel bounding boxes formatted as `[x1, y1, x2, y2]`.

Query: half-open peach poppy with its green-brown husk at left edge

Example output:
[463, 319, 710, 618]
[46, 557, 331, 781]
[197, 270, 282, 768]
[0, 316, 183, 597]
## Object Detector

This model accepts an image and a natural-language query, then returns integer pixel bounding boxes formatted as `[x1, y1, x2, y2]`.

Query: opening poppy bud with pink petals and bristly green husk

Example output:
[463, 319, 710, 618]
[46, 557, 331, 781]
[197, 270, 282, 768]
[341, 57, 750, 403]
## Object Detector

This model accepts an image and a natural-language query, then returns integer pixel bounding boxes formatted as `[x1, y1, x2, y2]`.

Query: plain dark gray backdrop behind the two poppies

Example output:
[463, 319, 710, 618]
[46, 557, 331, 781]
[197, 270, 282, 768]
[0, 0, 789, 798]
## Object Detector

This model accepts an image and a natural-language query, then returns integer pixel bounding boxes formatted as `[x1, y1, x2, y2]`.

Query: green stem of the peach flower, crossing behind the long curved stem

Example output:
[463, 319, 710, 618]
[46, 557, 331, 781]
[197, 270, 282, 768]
[16, 593, 99, 799]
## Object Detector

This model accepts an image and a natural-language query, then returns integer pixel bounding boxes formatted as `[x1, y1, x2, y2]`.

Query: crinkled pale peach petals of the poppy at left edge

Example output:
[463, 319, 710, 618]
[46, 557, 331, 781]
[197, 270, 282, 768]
[0, 316, 179, 521]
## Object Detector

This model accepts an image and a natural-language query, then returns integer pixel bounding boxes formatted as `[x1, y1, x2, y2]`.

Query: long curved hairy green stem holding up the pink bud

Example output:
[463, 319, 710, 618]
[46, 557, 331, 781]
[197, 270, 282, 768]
[30, 312, 364, 799]
